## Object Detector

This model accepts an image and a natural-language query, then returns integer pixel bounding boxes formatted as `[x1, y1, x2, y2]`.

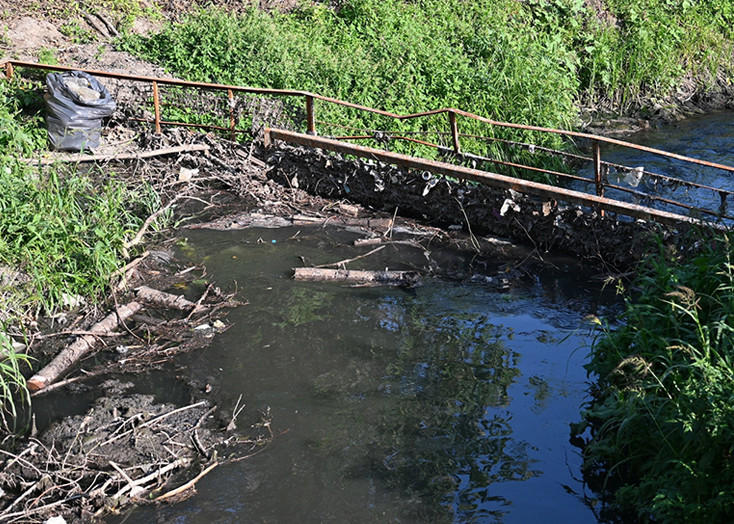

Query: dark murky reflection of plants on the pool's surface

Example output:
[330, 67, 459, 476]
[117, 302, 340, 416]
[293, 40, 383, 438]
[314, 290, 534, 522]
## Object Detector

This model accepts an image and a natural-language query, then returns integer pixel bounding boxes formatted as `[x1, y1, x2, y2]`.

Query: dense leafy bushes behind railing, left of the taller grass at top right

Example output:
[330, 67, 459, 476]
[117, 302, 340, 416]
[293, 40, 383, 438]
[122, 0, 577, 180]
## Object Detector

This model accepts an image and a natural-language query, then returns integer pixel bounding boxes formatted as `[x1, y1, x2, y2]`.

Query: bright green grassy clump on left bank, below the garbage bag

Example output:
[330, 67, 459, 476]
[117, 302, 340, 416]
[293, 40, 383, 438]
[0, 166, 150, 310]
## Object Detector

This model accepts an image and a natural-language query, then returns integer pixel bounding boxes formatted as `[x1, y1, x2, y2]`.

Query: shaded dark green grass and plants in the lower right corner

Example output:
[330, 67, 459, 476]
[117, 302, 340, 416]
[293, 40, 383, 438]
[575, 234, 734, 524]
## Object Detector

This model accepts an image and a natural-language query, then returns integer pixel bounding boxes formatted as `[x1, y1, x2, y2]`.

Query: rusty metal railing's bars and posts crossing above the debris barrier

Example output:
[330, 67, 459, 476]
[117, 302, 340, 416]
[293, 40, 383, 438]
[5, 60, 734, 227]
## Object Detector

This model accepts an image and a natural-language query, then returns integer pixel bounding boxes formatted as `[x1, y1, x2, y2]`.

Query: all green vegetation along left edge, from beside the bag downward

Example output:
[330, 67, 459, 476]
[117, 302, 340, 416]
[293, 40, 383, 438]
[0, 82, 159, 427]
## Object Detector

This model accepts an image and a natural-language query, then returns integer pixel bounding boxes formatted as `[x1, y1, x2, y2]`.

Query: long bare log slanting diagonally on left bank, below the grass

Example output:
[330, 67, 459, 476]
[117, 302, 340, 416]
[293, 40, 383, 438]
[27, 302, 143, 392]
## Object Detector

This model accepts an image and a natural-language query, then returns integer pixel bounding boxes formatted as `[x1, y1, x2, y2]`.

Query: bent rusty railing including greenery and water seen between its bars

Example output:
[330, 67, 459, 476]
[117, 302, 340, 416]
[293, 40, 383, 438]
[5, 60, 734, 226]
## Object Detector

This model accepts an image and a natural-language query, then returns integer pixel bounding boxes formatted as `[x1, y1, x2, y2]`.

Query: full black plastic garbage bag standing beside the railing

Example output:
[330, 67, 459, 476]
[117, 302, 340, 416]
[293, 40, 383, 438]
[45, 71, 116, 151]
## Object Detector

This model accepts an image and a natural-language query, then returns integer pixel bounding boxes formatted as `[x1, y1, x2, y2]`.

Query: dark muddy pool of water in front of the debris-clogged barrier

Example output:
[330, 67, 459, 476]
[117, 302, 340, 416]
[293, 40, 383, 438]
[110, 228, 614, 524]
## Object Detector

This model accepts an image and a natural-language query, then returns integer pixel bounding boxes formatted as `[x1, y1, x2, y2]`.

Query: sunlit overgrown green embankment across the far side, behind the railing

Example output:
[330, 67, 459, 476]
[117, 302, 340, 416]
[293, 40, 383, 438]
[118, 0, 734, 129]
